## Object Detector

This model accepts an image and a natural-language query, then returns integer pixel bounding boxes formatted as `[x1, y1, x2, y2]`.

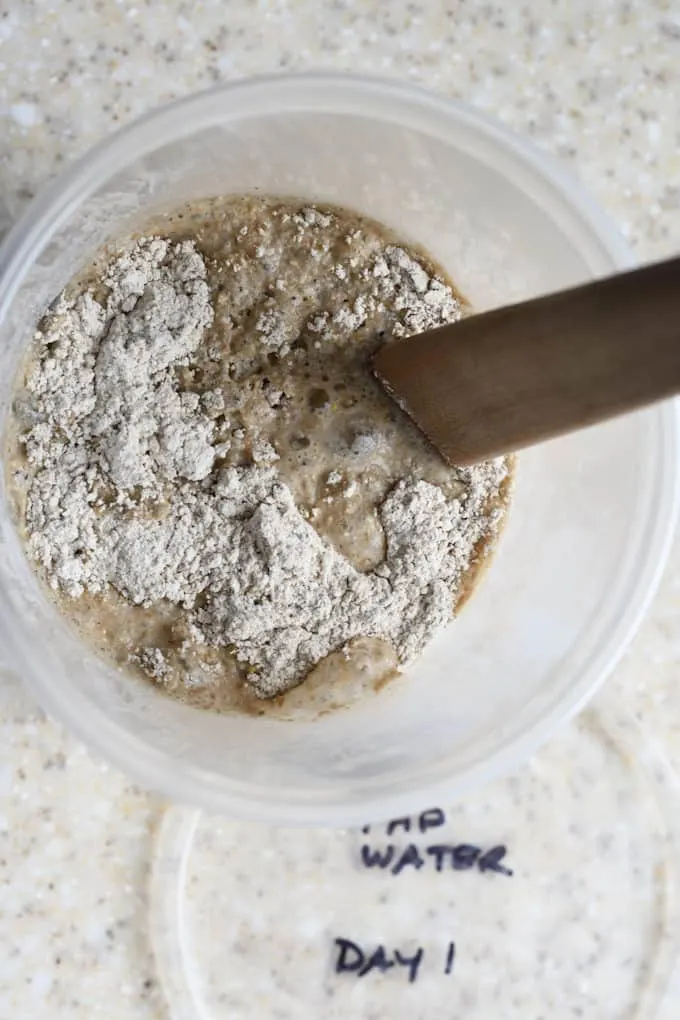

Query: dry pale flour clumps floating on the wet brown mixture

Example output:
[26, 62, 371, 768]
[16, 210, 507, 698]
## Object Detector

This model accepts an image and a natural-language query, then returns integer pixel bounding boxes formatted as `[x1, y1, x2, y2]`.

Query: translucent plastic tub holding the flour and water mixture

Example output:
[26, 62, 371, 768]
[0, 74, 677, 825]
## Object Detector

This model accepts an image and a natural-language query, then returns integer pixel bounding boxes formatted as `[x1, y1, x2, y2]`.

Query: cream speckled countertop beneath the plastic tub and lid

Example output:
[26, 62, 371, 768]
[0, 0, 680, 1020]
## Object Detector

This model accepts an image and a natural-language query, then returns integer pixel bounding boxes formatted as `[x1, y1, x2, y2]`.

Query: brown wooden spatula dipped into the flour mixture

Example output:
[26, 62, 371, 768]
[373, 258, 680, 464]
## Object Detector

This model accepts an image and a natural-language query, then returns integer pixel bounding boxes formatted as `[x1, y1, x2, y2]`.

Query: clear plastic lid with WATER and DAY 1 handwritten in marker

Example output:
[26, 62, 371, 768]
[151, 699, 680, 1020]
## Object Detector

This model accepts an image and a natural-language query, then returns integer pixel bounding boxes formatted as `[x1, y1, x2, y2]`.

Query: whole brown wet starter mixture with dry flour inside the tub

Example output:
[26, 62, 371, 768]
[10, 198, 508, 710]
